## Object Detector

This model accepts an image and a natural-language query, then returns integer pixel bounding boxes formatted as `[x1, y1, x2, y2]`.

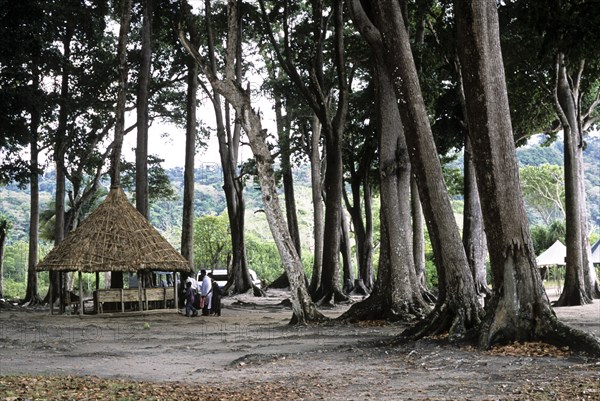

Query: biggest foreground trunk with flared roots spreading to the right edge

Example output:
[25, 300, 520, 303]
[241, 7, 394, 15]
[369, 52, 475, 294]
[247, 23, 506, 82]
[454, 0, 600, 353]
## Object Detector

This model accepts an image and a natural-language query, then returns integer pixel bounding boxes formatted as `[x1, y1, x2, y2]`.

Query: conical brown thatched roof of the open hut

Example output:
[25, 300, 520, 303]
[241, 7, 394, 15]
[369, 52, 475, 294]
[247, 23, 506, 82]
[36, 187, 191, 272]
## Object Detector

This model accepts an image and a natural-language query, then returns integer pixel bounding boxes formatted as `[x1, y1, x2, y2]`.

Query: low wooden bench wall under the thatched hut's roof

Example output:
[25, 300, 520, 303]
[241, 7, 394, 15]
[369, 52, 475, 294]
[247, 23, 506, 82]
[94, 287, 175, 313]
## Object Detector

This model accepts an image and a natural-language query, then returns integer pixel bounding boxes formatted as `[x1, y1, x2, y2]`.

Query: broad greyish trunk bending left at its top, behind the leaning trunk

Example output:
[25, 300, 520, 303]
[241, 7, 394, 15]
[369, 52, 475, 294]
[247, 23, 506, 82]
[341, 0, 428, 320]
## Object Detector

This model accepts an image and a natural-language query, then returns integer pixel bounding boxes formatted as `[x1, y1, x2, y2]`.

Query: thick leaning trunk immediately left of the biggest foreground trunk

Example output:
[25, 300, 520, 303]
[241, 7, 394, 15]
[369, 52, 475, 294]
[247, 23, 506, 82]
[375, 1, 482, 339]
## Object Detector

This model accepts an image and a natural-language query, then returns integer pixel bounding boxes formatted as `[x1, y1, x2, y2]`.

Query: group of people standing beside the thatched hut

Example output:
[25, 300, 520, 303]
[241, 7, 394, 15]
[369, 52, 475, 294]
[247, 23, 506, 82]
[185, 269, 221, 317]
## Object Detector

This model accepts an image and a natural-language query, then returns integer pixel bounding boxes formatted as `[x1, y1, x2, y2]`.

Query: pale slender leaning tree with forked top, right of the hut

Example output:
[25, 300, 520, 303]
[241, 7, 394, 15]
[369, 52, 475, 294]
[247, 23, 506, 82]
[179, 0, 324, 324]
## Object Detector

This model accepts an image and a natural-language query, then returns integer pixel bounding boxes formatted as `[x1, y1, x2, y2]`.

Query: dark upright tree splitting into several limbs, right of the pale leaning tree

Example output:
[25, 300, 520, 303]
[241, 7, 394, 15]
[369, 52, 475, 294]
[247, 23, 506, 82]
[260, 0, 349, 303]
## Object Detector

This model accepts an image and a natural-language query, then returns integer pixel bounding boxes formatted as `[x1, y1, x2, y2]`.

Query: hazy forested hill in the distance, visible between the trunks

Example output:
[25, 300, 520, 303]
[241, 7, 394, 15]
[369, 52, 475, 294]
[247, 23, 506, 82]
[0, 137, 600, 246]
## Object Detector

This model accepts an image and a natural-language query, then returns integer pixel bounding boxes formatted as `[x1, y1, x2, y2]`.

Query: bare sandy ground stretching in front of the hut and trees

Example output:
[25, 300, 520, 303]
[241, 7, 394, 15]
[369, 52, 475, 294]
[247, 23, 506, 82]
[0, 291, 600, 400]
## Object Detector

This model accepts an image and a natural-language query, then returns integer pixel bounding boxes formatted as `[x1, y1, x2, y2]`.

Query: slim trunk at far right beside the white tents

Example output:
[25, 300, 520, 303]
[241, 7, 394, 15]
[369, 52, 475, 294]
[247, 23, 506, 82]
[555, 54, 592, 306]
